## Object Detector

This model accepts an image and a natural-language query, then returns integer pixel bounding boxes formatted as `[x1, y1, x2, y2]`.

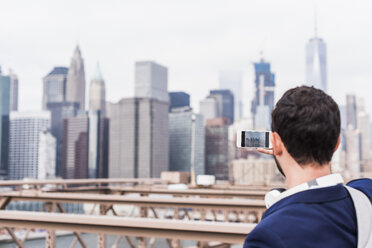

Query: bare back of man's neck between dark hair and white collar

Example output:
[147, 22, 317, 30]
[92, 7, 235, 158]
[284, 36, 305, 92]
[285, 164, 331, 189]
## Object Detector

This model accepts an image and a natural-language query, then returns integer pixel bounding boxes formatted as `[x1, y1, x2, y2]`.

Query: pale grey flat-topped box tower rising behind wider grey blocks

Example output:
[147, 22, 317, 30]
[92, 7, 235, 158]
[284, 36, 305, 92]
[134, 61, 169, 102]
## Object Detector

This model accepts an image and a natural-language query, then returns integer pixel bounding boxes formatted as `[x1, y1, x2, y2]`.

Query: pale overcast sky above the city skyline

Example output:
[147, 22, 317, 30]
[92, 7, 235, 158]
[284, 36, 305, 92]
[0, 0, 372, 116]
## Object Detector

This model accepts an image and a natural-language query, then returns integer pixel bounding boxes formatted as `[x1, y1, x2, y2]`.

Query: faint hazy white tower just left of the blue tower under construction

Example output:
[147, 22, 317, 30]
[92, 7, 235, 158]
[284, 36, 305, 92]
[219, 71, 243, 119]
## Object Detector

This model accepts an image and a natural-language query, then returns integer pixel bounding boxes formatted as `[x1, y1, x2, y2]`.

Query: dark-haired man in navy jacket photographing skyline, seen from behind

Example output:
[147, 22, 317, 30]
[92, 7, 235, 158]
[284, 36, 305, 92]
[244, 86, 372, 248]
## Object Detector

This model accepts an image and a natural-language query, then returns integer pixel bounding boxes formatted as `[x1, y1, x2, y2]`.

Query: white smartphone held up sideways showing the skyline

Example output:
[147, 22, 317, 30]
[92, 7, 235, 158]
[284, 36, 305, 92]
[236, 131, 272, 149]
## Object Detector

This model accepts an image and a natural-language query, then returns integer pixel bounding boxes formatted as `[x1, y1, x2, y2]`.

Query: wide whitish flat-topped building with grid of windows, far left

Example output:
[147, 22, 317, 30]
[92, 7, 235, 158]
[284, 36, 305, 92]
[8, 111, 55, 180]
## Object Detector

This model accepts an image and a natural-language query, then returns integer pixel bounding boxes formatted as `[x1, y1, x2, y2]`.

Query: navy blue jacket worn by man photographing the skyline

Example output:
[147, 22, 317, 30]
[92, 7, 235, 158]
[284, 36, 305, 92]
[244, 179, 372, 248]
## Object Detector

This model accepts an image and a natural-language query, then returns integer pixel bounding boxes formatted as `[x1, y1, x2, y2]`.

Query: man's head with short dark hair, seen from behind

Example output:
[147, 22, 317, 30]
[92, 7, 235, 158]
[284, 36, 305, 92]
[271, 86, 340, 176]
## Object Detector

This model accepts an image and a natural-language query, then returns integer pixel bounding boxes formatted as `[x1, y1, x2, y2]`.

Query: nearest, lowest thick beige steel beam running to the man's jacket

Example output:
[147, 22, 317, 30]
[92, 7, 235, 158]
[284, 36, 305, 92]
[0, 210, 255, 244]
